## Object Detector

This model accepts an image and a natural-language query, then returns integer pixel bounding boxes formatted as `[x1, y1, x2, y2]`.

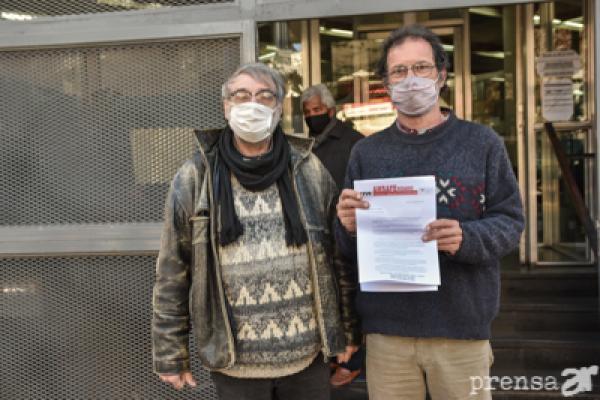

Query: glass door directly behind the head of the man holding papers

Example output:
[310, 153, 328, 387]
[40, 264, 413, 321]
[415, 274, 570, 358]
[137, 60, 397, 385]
[319, 13, 464, 136]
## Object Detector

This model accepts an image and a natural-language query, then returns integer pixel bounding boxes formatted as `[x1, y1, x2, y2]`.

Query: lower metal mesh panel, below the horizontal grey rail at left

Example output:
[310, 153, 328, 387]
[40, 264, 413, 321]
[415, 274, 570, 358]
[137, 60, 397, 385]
[0, 256, 216, 400]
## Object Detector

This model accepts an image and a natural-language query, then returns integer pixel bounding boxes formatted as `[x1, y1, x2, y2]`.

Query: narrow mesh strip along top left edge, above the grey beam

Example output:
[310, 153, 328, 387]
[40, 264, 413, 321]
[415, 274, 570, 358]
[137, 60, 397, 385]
[0, 0, 233, 21]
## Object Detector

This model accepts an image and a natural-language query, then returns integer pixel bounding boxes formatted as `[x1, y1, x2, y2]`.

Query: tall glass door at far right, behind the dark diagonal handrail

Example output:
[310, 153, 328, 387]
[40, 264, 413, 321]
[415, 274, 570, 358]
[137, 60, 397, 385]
[528, 0, 597, 265]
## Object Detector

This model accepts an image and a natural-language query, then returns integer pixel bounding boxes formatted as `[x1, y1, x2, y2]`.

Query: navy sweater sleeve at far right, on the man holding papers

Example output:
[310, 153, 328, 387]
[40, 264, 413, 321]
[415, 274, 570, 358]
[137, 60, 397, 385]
[454, 138, 525, 264]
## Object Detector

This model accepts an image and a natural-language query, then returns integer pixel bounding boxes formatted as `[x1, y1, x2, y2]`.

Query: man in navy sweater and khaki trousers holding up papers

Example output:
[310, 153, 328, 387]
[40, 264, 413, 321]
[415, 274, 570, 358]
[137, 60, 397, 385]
[336, 25, 524, 400]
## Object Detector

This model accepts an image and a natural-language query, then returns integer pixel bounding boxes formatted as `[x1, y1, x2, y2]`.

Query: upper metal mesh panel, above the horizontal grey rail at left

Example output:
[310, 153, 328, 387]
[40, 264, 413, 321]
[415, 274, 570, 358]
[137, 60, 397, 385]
[0, 37, 240, 225]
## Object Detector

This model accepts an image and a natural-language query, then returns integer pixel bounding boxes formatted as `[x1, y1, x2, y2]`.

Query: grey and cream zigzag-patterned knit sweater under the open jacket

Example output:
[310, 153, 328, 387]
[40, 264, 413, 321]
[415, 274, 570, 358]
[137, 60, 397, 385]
[214, 177, 321, 378]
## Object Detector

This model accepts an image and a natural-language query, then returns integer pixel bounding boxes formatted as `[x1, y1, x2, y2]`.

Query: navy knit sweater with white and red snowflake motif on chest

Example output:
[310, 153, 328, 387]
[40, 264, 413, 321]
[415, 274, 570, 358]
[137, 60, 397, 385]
[336, 114, 524, 339]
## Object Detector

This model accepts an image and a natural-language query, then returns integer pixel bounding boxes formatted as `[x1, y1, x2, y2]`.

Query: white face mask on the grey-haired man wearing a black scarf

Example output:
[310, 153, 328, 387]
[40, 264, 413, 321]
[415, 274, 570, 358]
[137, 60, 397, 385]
[229, 101, 281, 143]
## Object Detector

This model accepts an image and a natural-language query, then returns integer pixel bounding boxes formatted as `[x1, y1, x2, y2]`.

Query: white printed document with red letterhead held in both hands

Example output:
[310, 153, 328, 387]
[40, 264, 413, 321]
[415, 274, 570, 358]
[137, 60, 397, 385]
[354, 176, 440, 292]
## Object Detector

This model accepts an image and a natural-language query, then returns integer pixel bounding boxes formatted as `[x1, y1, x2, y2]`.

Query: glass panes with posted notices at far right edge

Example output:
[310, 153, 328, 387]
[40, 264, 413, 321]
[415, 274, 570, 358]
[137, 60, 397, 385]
[533, 0, 596, 263]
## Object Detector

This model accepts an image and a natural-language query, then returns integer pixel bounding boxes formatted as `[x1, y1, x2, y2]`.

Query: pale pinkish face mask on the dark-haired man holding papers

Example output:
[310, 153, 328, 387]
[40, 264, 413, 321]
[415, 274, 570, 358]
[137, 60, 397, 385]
[390, 76, 439, 117]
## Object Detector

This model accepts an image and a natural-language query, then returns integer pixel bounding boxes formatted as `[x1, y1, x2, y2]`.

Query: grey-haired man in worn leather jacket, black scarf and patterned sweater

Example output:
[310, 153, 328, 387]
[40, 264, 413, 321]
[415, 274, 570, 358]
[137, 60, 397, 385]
[152, 64, 360, 400]
